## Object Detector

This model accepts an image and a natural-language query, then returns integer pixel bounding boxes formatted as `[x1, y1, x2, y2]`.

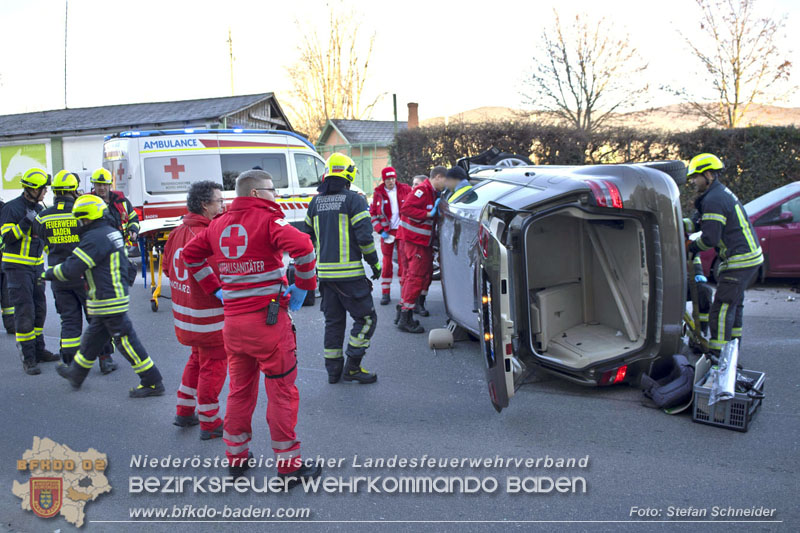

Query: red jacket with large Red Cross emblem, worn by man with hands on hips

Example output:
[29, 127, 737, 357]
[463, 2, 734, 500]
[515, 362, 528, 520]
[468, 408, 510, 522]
[181, 197, 317, 316]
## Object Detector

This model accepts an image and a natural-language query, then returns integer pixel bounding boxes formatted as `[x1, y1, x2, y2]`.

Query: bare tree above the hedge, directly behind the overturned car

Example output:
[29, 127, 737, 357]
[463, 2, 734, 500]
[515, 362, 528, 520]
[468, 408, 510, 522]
[523, 10, 648, 134]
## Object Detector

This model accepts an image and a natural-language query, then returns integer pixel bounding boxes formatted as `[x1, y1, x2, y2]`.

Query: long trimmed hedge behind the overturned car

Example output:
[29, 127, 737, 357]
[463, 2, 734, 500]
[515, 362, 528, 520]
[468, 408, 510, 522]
[390, 121, 800, 207]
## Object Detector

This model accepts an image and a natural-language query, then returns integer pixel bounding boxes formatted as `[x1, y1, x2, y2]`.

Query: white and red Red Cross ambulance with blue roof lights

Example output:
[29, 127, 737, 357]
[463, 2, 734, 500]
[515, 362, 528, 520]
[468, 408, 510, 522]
[103, 128, 334, 234]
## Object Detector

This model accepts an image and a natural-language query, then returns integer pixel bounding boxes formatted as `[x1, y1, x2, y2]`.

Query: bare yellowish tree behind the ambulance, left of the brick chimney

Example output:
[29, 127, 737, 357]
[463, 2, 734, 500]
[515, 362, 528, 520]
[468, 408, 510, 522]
[287, 6, 383, 141]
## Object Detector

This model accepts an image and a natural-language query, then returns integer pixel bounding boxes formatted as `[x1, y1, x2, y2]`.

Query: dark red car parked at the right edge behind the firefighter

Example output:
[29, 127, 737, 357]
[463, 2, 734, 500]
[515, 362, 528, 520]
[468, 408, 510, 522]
[700, 181, 800, 280]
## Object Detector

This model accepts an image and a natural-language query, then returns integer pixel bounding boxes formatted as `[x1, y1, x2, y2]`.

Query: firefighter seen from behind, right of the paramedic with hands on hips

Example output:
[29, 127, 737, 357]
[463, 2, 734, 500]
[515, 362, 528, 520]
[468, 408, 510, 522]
[305, 152, 382, 383]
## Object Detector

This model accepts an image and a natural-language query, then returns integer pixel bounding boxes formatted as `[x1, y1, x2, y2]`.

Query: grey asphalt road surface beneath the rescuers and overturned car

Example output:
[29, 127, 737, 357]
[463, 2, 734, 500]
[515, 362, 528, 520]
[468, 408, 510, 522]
[0, 270, 800, 531]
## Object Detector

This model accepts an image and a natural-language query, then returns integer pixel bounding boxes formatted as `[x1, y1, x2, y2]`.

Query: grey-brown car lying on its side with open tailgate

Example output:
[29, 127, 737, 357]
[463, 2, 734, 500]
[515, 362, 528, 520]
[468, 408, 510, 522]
[439, 161, 686, 411]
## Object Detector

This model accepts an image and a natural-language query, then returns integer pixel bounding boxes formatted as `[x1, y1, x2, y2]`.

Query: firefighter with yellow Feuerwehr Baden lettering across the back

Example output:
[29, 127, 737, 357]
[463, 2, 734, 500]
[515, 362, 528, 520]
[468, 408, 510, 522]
[33, 170, 88, 365]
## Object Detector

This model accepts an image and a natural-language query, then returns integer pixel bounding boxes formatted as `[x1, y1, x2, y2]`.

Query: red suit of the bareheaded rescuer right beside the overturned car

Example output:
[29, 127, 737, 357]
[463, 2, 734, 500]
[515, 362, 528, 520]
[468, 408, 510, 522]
[397, 180, 436, 310]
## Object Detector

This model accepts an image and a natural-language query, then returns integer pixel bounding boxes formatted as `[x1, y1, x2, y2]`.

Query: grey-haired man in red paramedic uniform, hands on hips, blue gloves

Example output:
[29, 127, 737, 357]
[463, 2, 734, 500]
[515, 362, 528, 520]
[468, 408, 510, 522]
[182, 170, 321, 488]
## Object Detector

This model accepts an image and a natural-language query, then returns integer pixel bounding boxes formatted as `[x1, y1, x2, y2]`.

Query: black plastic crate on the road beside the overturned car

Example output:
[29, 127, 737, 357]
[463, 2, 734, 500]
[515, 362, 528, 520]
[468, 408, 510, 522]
[692, 370, 764, 431]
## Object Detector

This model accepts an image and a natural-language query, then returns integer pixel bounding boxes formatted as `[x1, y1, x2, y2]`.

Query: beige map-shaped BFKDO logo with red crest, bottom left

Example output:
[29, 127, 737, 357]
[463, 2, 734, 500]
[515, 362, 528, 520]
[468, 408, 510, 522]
[11, 437, 111, 527]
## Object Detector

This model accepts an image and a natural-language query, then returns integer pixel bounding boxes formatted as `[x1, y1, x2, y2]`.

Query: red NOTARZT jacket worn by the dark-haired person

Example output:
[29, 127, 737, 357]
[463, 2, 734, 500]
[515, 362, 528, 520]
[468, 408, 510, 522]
[164, 213, 225, 346]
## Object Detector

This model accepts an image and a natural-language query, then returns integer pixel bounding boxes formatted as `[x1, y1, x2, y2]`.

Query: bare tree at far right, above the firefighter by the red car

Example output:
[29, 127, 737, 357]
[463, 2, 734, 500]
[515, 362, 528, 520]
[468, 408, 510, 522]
[676, 0, 792, 128]
